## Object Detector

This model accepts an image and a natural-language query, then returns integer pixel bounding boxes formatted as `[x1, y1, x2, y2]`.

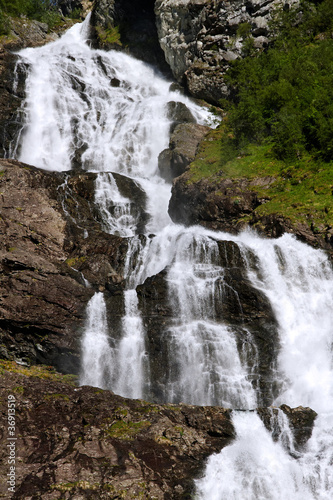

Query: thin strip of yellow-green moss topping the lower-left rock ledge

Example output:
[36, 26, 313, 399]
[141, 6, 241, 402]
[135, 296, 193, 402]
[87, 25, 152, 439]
[0, 359, 77, 386]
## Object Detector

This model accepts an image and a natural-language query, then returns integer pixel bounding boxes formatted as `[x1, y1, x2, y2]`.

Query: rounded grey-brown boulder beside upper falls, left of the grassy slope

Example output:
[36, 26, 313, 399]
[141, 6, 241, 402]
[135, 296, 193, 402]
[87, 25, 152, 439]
[158, 123, 210, 182]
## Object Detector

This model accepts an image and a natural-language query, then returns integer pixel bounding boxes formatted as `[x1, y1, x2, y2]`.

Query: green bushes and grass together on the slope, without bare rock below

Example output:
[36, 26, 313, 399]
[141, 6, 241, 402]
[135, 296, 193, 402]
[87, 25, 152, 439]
[188, 0, 333, 235]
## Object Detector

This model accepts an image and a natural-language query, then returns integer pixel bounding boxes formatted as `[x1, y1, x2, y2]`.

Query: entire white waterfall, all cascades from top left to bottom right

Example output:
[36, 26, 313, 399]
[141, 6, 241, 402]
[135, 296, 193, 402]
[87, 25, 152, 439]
[15, 15, 333, 500]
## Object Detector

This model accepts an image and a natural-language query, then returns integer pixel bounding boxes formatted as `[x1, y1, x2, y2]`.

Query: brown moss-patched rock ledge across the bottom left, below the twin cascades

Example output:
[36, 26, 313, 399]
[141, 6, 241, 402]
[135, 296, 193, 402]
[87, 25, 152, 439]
[0, 361, 316, 500]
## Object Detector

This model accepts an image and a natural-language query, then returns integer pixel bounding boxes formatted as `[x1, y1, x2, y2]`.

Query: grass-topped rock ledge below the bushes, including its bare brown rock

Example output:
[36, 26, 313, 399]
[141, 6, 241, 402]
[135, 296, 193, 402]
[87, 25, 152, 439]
[169, 128, 333, 255]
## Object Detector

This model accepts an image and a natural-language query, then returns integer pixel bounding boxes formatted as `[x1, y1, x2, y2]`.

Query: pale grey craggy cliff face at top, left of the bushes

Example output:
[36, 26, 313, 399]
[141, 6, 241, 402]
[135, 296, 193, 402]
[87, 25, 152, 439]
[155, 0, 295, 104]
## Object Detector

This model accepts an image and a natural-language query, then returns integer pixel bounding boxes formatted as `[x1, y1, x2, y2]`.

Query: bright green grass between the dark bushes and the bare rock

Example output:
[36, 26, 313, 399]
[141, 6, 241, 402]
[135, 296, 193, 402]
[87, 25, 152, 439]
[188, 127, 333, 233]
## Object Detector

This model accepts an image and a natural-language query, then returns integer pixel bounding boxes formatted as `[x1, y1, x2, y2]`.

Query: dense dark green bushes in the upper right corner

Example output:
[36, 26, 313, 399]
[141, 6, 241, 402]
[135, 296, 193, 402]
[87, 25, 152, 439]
[223, 0, 333, 161]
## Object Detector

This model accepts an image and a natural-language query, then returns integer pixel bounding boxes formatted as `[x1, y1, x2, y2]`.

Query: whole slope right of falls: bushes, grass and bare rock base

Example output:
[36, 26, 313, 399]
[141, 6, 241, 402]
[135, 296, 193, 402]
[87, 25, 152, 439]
[170, 0, 333, 249]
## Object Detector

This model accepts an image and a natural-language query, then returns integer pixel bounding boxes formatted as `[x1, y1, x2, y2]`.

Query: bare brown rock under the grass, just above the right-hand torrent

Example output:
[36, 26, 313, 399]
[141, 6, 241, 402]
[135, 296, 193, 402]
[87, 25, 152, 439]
[169, 170, 333, 253]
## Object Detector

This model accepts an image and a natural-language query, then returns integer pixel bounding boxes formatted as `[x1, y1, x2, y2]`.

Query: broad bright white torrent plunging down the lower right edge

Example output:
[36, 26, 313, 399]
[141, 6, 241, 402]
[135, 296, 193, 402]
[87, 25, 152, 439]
[197, 234, 333, 500]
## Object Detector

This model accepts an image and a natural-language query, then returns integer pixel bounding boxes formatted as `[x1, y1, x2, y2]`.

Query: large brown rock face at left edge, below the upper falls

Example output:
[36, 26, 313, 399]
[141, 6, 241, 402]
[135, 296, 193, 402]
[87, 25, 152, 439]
[0, 160, 147, 373]
